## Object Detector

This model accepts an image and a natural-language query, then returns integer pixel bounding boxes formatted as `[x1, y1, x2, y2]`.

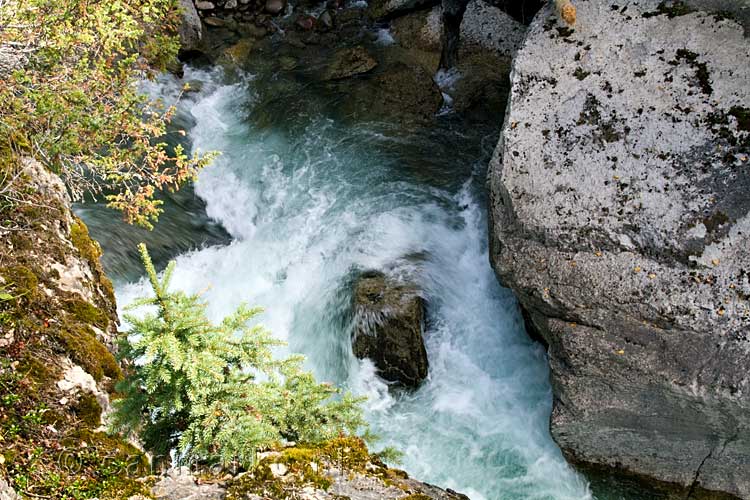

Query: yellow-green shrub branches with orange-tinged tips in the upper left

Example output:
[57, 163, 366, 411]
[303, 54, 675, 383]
[0, 0, 217, 227]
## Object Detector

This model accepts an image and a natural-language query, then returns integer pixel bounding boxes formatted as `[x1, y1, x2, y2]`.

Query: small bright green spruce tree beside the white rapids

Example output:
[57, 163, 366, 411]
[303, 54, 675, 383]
[113, 245, 364, 465]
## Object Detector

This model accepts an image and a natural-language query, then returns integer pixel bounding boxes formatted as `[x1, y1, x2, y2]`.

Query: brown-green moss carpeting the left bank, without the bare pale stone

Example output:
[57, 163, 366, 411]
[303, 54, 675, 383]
[0, 171, 147, 500]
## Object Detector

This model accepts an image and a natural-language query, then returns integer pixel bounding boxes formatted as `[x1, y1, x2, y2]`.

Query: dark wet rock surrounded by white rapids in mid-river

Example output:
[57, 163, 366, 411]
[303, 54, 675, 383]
[352, 272, 428, 387]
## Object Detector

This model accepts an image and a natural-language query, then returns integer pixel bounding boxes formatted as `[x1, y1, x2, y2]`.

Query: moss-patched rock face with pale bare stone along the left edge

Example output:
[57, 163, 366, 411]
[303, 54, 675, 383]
[0, 158, 145, 500]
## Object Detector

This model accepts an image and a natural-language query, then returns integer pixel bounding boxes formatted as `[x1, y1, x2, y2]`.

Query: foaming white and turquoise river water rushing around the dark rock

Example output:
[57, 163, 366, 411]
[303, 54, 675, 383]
[79, 52, 640, 500]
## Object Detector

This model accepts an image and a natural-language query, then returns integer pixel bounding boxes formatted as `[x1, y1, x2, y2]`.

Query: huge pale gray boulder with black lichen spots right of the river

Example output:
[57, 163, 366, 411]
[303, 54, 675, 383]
[489, 0, 750, 498]
